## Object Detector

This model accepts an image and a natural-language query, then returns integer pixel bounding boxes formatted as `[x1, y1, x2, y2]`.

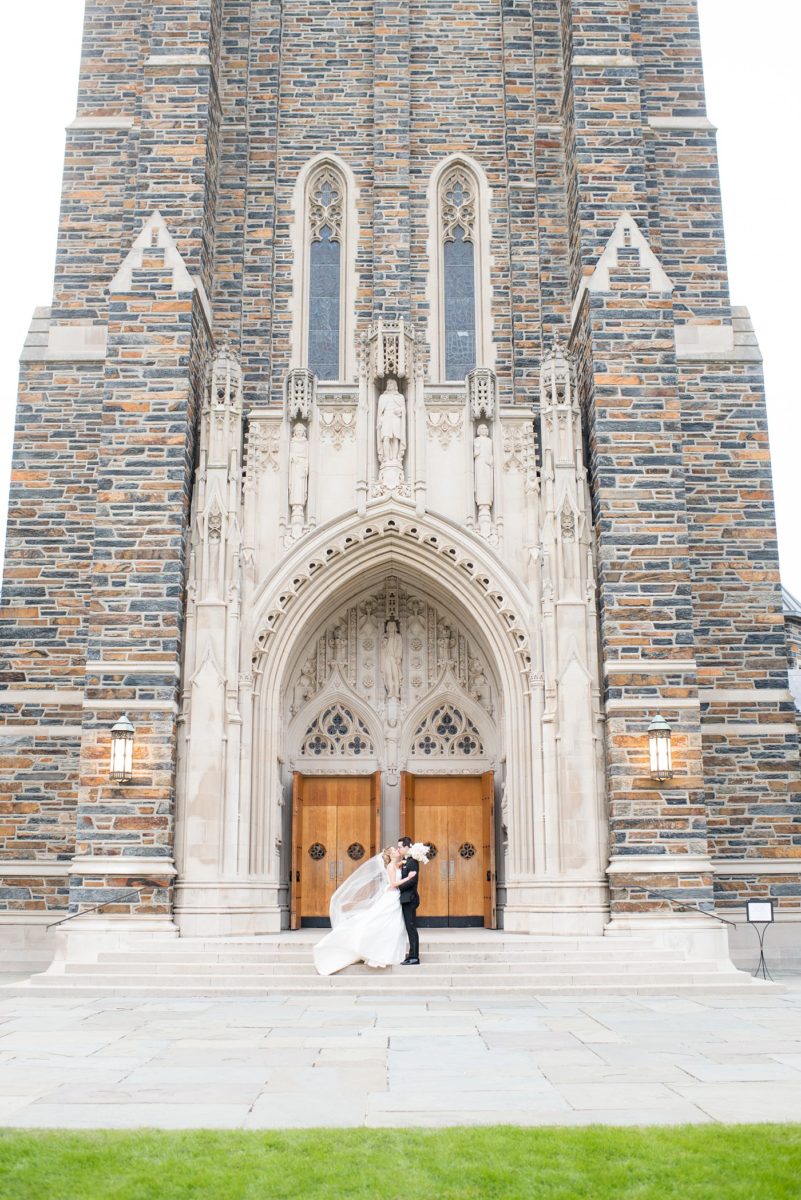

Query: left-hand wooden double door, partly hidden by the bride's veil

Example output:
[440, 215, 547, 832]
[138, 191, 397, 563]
[290, 772, 381, 929]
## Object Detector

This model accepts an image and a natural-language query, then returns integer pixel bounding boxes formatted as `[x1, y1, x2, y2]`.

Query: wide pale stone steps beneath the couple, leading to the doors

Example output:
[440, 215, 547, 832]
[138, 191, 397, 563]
[2, 930, 772, 1000]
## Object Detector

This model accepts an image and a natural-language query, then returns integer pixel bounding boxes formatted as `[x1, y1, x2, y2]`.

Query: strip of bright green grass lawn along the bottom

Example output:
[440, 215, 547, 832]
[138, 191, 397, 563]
[0, 1124, 801, 1200]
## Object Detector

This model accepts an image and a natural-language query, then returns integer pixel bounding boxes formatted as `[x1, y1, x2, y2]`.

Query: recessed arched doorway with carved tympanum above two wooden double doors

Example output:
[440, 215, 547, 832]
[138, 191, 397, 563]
[284, 572, 504, 928]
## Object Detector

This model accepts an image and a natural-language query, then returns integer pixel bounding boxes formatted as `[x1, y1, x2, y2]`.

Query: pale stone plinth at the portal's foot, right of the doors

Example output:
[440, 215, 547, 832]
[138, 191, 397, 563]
[499, 880, 609, 937]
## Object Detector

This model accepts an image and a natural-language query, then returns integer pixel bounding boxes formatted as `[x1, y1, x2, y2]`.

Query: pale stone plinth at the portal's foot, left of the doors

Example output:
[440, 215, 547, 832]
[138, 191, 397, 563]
[175, 880, 289, 937]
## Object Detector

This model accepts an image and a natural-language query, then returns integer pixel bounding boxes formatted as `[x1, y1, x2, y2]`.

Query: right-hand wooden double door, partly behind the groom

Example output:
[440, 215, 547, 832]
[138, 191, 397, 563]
[401, 772, 495, 929]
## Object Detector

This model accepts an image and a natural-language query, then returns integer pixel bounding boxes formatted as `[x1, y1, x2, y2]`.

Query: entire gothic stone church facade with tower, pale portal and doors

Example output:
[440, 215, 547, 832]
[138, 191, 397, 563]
[0, 0, 801, 947]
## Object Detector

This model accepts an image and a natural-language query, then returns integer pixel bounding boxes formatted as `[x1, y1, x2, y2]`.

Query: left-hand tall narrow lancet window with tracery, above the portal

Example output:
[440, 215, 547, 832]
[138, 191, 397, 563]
[307, 163, 345, 379]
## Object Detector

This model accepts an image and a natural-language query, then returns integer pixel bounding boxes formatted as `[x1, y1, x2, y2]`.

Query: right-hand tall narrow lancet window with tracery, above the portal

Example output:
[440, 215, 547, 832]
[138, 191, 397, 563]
[439, 164, 477, 379]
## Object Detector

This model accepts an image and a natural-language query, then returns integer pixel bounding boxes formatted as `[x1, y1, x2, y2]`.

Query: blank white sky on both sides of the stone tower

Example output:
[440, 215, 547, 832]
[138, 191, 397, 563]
[0, 0, 801, 596]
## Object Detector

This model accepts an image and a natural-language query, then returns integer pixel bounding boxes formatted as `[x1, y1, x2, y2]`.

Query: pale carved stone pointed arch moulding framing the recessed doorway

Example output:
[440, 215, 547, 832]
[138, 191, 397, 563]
[241, 502, 541, 886]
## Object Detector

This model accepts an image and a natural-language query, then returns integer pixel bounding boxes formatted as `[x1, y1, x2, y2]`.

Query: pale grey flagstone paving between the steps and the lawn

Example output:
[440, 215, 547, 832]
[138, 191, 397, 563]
[0, 978, 801, 1129]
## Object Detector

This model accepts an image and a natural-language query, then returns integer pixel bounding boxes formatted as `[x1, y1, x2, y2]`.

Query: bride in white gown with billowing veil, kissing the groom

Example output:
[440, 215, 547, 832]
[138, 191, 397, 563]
[314, 846, 416, 974]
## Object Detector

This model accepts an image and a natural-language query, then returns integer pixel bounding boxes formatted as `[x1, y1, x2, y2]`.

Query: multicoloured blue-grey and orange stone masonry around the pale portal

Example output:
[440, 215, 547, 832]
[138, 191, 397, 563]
[0, 0, 801, 936]
